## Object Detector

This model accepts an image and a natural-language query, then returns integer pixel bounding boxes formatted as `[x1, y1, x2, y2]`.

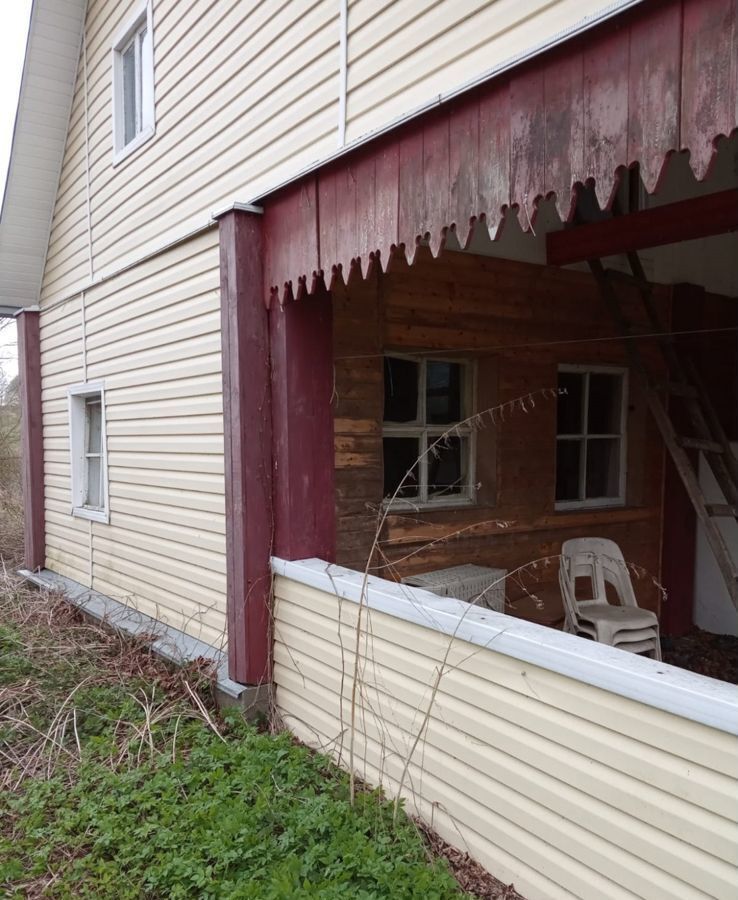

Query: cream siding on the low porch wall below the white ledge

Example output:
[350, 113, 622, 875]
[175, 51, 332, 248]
[274, 576, 738, 900]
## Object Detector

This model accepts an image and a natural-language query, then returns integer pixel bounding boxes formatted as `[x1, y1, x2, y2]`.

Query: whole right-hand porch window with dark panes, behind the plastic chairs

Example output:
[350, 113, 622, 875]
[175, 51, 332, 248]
[556, 366, 627, 509]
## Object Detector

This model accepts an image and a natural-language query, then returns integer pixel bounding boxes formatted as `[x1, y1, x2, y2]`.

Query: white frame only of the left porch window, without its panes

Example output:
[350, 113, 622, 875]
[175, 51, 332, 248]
[382, 350, 477, 512]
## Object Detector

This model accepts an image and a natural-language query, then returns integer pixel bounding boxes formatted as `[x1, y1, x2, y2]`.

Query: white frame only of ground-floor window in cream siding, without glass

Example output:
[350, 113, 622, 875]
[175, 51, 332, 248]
[67, 381, 110, 524]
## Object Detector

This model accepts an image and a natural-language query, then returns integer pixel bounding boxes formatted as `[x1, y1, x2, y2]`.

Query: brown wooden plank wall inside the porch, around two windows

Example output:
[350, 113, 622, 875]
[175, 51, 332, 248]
[334, 247, 666, 622]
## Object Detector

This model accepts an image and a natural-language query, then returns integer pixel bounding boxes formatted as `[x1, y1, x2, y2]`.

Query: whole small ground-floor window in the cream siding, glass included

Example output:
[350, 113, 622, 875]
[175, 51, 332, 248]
[69, 382, 109, 522]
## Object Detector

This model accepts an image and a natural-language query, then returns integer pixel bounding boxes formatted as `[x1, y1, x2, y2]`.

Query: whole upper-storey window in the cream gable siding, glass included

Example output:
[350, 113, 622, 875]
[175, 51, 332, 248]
[113, 2, 155, 162]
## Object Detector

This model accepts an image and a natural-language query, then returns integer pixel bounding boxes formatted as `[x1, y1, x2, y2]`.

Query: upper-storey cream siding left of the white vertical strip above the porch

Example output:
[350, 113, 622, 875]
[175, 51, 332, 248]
[42, 0, 339, 303]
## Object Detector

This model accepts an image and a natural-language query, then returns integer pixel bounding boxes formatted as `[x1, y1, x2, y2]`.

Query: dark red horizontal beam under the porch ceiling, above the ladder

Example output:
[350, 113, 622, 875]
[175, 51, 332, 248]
[546, 190, 738, 266]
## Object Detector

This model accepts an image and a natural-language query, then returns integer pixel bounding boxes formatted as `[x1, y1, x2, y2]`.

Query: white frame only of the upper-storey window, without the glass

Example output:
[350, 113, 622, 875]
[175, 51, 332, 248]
[112, 0, 156, 165]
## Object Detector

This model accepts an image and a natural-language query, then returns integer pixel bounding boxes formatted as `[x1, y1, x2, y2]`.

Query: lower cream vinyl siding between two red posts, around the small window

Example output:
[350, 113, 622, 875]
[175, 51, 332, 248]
[41, 228, 226, 645]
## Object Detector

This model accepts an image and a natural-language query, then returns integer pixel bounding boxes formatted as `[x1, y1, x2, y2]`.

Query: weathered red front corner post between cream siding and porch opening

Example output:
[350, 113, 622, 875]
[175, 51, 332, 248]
[220, 211, 272, 684]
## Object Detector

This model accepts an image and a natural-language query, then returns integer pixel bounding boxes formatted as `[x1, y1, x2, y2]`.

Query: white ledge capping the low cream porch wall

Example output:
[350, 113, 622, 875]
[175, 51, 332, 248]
[272, 557, 738, 735]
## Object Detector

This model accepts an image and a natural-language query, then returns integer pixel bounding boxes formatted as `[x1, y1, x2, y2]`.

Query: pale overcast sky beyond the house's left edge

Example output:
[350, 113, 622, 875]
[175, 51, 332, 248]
[0, 0, 31, 377]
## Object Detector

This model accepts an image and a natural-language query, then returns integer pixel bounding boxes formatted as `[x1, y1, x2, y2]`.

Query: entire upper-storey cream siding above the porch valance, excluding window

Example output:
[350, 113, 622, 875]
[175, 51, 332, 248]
[41, 0, 628, 302]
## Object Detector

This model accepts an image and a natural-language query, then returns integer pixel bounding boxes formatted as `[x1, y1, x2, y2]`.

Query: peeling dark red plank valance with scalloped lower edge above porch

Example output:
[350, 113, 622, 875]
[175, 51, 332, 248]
[265, 0, 738, 297]
